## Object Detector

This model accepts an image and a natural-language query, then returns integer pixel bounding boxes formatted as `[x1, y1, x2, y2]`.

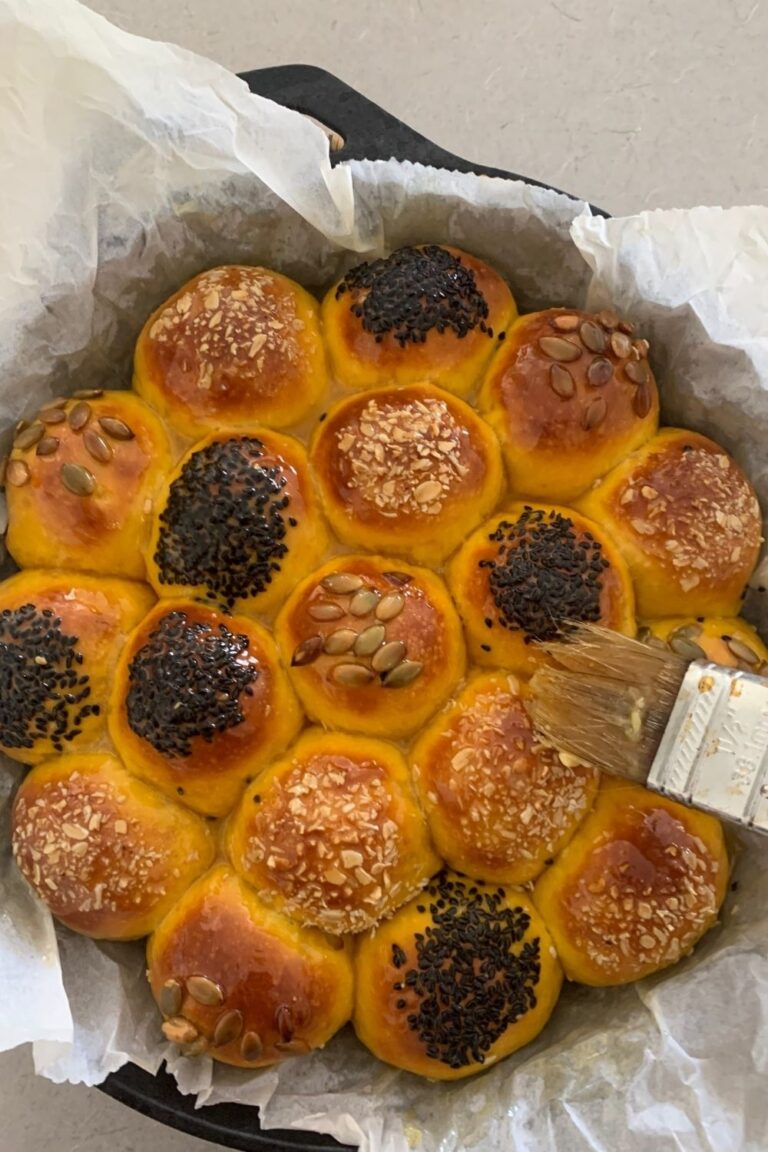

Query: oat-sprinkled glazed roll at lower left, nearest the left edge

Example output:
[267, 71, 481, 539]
[12, 752, 215, 940]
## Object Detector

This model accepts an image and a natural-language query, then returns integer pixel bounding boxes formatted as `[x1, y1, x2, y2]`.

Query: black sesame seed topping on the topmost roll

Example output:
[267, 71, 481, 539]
[336, 244, 493, 348]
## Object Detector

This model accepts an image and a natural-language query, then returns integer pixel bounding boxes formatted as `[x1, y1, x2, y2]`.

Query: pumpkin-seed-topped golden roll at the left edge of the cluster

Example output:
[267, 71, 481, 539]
[5, 389, 174, 579]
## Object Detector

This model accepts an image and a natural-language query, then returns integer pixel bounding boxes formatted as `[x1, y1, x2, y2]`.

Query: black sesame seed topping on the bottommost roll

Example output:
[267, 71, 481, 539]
[394, 873, 541, 1068]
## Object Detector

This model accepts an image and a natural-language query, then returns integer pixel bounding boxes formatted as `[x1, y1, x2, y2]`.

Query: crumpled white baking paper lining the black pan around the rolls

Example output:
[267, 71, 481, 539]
[0, 0, 768, 1152]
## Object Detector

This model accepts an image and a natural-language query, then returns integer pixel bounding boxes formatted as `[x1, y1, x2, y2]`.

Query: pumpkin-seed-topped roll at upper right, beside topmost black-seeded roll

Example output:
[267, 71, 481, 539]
[479, 308, 659, 503]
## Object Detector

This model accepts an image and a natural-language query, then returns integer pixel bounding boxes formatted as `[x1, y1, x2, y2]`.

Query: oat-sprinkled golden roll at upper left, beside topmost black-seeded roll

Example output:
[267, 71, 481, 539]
[134, 265, 327, 440]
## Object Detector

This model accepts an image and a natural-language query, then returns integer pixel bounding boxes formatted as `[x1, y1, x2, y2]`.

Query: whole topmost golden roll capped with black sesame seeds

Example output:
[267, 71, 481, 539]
[322, 244, 517, 396]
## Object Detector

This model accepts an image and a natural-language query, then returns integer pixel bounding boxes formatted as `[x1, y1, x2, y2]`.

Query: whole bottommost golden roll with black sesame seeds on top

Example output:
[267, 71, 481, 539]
[352, 872, 563, 1081]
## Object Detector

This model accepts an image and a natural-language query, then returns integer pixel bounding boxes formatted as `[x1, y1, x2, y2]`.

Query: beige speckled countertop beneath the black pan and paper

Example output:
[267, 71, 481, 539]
[6, 0, 768, 1152]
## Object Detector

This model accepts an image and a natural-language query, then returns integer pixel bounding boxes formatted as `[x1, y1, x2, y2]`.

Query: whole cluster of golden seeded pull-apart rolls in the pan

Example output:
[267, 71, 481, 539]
[0, 245, 755, 1079]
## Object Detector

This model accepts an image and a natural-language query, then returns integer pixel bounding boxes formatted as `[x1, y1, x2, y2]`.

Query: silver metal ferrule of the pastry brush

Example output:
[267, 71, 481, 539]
[648, 661, 768, 833]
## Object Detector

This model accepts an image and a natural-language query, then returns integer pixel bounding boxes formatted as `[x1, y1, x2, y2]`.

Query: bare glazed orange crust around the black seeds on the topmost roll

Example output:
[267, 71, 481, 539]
[322, 244, 517, 396]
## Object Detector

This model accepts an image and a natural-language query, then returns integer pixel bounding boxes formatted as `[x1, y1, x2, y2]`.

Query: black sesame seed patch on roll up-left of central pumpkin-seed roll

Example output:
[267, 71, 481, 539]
[154, 437, 292, 609]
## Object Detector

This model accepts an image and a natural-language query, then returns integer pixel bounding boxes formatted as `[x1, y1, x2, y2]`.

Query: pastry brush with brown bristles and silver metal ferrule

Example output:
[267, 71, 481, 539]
[530, 623, 768, 833]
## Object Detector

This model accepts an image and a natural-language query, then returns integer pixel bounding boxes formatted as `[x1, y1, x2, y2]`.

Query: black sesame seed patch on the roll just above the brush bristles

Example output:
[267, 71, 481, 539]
[478, 507, 609, 644]
